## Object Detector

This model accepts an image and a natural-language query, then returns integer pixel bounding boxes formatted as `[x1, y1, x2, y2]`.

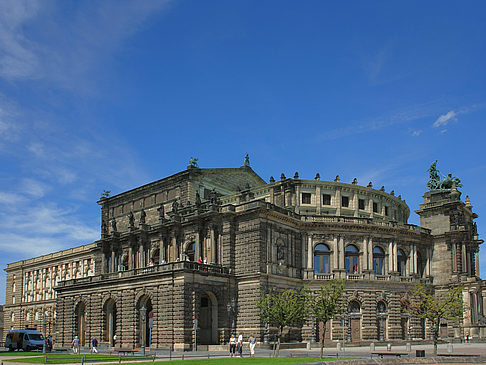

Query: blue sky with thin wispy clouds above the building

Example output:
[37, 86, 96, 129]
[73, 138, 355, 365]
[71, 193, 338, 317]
[0, 0, 486, 303]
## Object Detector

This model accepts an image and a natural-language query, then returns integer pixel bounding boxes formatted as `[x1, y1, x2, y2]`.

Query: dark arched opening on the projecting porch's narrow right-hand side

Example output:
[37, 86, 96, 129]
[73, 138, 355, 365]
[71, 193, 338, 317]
[198, 292, 219, 345]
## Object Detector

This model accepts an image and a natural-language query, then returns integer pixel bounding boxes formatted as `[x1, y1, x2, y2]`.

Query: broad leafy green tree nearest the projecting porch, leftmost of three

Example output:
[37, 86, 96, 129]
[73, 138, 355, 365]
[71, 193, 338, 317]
[258, 288, 308, 357]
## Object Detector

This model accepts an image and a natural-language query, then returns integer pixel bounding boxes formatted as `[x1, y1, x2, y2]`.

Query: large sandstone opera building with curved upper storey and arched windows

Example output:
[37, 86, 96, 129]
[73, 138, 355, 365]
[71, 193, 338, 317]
[5, 164, 486, 350]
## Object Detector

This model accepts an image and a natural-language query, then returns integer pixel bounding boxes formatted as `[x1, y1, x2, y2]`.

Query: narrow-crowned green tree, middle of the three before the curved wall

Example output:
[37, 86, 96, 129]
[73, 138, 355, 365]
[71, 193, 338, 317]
[308, 280, 345, 359]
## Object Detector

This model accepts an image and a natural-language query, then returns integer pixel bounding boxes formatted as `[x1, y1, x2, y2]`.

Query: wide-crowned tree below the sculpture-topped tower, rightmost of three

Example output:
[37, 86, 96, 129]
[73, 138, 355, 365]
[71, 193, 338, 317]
[402, 285, 464, 356]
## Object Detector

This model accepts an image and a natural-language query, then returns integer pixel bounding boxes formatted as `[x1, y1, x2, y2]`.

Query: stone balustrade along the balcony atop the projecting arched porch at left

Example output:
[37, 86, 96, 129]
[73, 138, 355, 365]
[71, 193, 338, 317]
[57, 261, 229, 288]
